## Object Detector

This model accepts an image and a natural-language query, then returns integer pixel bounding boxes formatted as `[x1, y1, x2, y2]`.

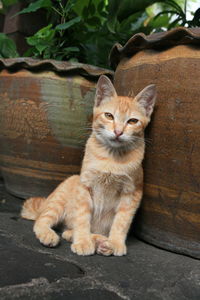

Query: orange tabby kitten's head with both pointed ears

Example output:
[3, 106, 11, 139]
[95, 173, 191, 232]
[92, 75, 156, 151]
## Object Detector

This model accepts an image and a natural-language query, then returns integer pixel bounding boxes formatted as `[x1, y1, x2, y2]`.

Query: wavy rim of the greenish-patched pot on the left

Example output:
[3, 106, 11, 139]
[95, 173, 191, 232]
[0, 57, 114, 78]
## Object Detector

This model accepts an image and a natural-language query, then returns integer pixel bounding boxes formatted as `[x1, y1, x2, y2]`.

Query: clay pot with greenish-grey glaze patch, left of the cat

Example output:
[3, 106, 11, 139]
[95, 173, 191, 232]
[0, 58, 112, 198]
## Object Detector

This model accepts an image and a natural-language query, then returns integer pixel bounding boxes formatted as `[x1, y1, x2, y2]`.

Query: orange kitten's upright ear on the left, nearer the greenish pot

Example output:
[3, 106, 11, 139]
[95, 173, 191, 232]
[95, 75, 117, 106]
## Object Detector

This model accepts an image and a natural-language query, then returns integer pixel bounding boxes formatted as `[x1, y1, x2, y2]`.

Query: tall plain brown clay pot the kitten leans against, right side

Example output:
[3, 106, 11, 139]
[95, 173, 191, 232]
[111, 28, 200, 258]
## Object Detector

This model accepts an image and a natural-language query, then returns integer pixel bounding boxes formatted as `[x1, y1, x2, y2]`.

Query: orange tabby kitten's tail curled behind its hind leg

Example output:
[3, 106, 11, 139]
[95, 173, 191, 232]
[21, 197, 47, 220]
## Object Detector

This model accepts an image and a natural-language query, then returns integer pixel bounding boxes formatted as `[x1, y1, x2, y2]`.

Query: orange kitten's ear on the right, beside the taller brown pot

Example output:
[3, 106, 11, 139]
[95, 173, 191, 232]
[135, 84, 157, 117]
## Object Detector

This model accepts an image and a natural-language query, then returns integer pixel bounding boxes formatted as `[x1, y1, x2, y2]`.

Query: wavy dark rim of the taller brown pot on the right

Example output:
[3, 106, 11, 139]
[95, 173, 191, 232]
[109, 27, 200, 70]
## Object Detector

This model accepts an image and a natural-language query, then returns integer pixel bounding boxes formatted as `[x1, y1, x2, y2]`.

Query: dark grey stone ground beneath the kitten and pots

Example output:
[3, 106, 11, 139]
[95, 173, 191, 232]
[0, 182, 200, 300]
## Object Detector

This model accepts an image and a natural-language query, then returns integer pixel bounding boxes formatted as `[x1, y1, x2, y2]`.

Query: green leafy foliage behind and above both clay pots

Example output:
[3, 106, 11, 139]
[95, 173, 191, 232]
[1, 0, 200, 67]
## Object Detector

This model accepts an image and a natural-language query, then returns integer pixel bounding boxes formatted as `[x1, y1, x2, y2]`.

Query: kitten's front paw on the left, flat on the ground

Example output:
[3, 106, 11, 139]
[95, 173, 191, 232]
[71, 239, 95, 255]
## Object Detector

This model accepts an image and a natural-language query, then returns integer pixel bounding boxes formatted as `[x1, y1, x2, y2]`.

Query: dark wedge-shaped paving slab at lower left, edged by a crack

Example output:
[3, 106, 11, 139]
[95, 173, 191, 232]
[0, 233, 84, 287]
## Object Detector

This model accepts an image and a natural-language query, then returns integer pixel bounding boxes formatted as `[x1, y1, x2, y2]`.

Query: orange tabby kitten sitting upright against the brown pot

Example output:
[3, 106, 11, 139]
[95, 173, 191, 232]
[21, 76, 156, 256]
